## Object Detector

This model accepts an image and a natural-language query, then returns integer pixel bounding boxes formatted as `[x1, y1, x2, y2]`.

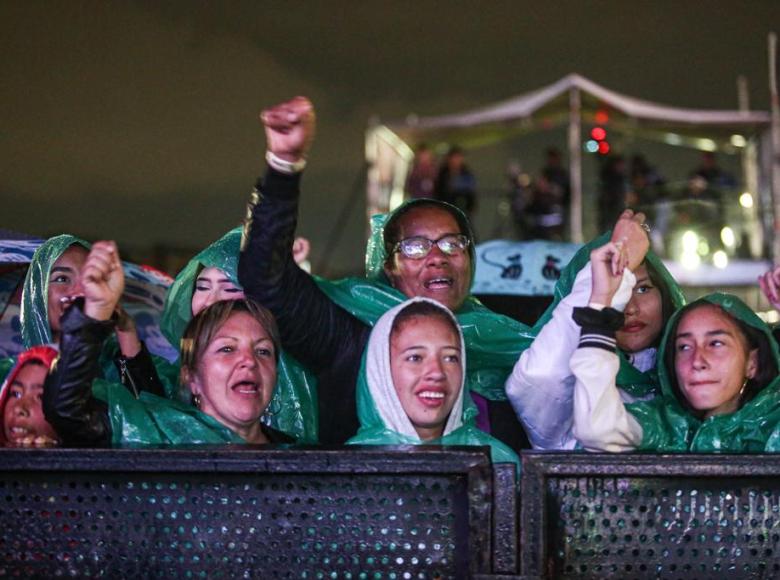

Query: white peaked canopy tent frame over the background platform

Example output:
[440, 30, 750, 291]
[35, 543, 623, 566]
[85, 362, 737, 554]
[366, 74, 780, 254]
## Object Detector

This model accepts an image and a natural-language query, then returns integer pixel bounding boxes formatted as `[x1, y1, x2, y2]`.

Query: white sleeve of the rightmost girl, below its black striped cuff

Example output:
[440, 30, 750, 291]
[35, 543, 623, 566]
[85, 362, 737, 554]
[571, 347, 642, 451]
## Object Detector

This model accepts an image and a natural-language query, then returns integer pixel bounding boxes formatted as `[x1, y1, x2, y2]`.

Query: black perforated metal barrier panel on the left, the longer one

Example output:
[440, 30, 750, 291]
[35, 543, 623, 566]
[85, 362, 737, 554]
[0, 446, 518, 579]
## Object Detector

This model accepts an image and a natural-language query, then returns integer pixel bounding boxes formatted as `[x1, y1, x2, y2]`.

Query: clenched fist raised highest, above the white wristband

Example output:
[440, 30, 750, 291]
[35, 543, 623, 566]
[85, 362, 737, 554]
[260, 97, 315, 163]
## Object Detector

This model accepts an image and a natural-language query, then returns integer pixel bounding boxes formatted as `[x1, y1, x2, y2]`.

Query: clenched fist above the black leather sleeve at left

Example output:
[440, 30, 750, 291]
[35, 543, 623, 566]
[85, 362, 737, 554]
[81, 242, 125, 320]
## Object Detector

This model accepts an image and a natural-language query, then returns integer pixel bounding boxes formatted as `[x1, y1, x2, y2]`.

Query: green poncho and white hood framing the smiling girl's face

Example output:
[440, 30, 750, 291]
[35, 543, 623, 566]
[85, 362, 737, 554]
[347, 297, 520, 469]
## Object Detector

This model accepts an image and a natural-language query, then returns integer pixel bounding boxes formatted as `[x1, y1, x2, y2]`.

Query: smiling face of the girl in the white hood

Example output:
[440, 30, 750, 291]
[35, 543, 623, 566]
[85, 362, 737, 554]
[390, 316, 463, 440]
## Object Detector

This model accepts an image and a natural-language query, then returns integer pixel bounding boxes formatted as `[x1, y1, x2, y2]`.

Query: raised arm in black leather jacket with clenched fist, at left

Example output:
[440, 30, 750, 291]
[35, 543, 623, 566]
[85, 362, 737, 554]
[43, 242, 124, 445]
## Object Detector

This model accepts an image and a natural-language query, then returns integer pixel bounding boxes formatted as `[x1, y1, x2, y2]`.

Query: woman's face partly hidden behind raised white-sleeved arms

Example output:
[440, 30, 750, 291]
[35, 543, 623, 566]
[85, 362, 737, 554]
[616, 264, 664, 353]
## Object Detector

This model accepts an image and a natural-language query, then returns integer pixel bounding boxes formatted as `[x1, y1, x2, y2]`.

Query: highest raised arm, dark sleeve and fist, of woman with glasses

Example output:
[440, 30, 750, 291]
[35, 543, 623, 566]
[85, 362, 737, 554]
[238, 97, 369, 372]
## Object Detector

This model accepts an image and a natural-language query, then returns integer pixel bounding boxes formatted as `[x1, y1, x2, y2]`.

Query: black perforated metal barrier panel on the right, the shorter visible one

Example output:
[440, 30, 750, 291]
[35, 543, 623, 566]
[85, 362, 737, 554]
[520, 452, 780, 580]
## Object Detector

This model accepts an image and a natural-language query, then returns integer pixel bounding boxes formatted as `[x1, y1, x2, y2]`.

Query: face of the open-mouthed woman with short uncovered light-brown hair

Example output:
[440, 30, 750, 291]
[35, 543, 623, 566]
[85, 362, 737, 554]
[189, 312, 276, 439]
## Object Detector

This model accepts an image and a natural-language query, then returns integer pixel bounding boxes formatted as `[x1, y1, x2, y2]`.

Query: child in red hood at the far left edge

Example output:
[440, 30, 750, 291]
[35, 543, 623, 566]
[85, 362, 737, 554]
[0, 346, 58, 447]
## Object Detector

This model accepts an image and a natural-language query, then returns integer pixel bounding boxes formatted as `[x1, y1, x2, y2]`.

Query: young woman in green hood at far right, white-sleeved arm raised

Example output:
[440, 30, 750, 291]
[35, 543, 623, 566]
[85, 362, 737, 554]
[571, 238, 780, 452]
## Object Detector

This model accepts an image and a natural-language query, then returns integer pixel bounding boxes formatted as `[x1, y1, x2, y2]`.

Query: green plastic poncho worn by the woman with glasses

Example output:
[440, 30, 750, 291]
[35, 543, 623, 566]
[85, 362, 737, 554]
[315, 200, 533, 401]
